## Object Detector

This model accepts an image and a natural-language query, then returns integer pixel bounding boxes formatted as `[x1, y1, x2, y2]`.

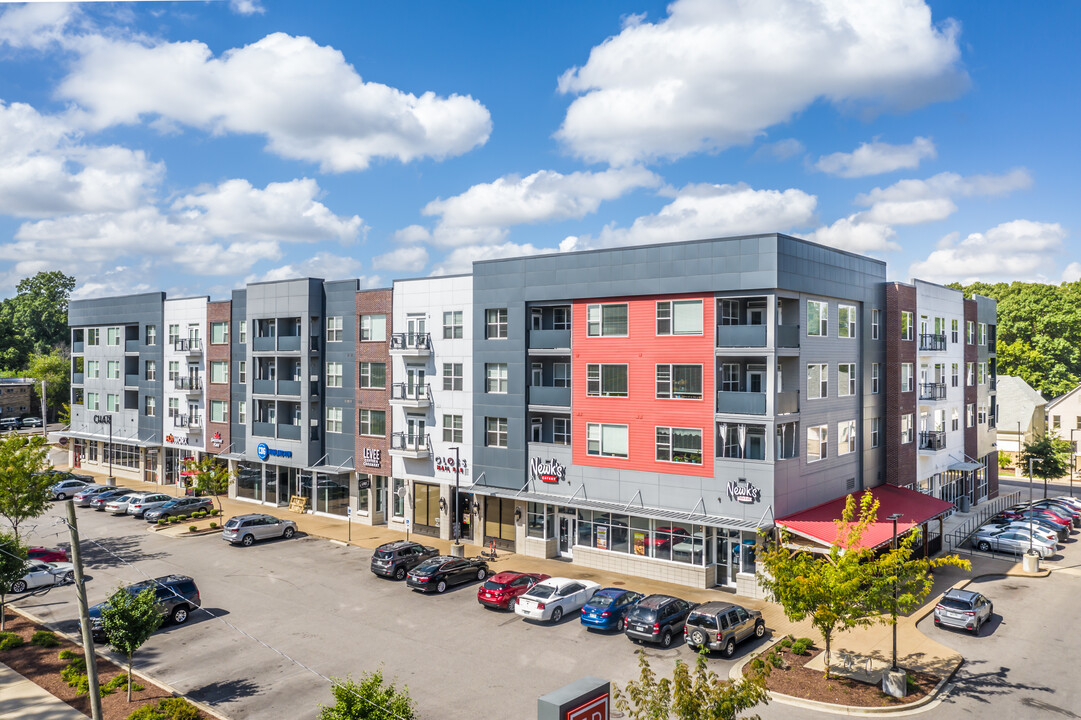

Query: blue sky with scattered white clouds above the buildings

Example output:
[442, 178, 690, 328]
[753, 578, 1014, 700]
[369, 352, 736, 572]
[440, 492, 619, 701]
[0, 0, 1081, 298]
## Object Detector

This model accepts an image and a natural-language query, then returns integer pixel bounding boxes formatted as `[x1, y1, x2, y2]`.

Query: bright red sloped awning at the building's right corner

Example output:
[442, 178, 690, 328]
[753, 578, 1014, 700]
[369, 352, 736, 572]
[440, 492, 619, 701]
[777, 485, 953, 547]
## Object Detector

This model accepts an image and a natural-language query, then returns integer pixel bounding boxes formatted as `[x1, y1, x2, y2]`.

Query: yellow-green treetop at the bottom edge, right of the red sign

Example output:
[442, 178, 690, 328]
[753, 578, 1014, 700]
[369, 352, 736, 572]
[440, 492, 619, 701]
[612, 652, 769, 720]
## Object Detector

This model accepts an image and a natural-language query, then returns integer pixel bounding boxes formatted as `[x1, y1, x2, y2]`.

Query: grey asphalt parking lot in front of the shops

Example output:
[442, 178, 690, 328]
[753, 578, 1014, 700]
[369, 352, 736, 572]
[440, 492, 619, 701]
[16, 504, 769, 719]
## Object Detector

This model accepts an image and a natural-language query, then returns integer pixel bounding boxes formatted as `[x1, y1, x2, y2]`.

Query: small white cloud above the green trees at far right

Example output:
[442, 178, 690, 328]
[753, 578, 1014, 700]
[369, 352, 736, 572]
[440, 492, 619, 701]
[908, 219, 1066, 283]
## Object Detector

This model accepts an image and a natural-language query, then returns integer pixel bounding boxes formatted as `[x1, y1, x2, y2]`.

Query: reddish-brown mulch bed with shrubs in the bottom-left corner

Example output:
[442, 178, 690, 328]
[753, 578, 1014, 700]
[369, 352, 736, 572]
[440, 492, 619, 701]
[0, 613, 210, 720]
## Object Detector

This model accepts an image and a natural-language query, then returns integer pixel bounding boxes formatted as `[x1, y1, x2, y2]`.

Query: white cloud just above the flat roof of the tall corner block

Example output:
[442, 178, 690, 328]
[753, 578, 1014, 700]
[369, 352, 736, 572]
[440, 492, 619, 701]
[563, 183, 817, 250]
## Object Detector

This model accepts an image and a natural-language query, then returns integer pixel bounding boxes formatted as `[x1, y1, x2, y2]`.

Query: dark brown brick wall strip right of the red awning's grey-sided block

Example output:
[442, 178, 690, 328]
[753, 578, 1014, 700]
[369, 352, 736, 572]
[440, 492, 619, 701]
[882, 282, 919, 486]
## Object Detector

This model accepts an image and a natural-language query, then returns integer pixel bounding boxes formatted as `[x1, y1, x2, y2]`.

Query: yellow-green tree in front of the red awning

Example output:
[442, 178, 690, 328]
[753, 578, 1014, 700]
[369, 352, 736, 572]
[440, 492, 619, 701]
[759, 492, 967, 678]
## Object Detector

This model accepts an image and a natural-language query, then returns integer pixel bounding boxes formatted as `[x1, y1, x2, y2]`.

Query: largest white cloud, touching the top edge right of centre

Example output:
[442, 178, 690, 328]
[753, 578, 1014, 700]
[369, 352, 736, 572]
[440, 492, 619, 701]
[557, 0, 967, 164]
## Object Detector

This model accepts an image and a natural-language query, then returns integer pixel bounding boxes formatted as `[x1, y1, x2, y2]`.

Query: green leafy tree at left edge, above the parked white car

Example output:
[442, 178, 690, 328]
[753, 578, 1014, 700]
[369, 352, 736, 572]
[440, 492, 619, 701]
[0, 435, 53, 539]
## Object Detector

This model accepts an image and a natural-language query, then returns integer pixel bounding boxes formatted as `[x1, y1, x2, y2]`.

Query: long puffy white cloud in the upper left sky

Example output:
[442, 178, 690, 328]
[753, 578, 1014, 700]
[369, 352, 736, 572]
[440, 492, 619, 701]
[57, 32, 492, 172]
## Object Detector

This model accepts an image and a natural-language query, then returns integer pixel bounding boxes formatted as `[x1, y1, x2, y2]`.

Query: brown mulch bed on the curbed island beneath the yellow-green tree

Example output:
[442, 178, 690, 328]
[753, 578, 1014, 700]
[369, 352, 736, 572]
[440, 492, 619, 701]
[743, 644, 940, 707]
